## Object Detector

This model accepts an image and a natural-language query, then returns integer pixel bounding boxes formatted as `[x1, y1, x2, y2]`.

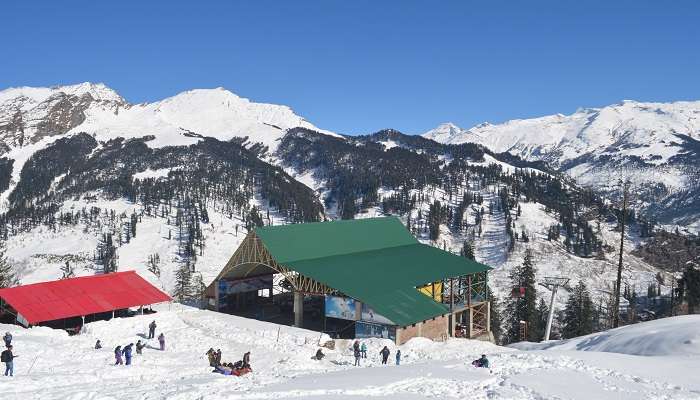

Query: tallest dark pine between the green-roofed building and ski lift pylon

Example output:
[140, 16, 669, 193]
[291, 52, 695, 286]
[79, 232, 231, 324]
[506, 249, 541, 343]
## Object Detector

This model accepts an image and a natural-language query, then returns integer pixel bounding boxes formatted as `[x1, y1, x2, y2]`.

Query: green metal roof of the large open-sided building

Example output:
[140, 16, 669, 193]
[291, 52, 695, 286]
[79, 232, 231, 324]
[256, 217, 489, 326]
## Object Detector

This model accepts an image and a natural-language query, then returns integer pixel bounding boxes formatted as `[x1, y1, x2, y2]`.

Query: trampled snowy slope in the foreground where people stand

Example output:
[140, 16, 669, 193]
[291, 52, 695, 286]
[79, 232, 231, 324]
[0, 305, 700, 400]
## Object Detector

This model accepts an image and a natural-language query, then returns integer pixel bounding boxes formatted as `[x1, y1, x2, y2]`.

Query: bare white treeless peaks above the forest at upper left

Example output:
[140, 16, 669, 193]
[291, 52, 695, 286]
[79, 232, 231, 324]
[0, 82, 336, 156]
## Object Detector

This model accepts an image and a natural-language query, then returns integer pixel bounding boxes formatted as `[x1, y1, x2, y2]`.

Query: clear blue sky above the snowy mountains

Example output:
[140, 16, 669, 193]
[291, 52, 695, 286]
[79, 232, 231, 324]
[0, 0, 700, 134]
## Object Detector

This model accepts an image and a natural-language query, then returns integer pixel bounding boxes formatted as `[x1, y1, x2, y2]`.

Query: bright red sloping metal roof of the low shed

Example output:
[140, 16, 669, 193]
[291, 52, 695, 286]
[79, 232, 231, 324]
[0, 271, 171, 325]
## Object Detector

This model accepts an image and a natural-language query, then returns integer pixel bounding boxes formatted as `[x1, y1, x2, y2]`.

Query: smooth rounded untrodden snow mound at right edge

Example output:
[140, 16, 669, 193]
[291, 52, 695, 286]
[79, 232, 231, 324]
[511, 315, 700, 356]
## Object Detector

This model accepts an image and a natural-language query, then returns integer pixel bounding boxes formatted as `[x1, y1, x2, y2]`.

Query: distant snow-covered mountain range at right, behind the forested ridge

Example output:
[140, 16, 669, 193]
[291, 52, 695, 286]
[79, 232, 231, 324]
[423, 101, 700, 230]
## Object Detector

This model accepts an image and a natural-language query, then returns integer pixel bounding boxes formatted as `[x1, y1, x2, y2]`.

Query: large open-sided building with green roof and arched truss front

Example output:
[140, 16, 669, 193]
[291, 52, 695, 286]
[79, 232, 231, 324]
[206, 217, 490, 344]
